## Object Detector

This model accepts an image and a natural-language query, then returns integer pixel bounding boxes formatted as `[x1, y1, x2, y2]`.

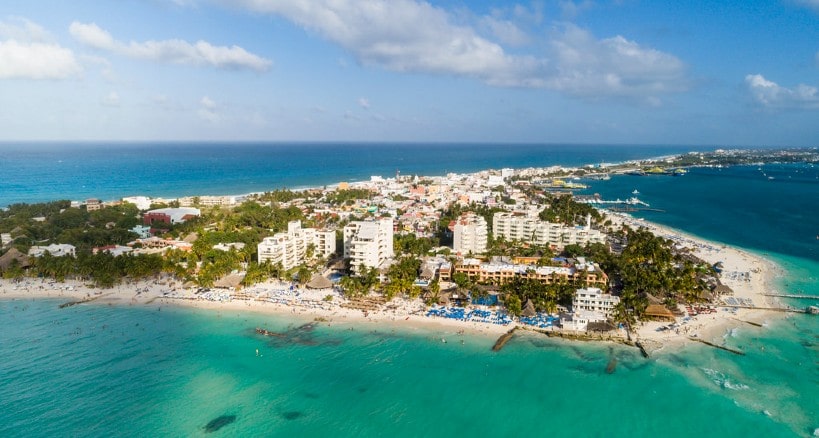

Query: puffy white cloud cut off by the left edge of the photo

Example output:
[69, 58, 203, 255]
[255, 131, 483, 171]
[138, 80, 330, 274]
[0, 18, 82, 79]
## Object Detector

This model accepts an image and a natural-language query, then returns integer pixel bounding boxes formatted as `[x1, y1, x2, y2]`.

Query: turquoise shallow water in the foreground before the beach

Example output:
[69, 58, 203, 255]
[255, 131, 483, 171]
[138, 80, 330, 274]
[0, 301, 815, 437]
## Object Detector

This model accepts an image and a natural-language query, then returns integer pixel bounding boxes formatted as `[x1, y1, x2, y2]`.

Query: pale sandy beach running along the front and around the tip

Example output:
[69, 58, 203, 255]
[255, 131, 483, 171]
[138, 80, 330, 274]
[0, 216, 796, 354]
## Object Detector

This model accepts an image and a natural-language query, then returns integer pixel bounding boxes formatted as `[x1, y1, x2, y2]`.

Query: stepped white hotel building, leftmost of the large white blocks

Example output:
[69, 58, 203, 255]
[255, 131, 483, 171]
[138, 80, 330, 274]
[257, 221, 336, 269]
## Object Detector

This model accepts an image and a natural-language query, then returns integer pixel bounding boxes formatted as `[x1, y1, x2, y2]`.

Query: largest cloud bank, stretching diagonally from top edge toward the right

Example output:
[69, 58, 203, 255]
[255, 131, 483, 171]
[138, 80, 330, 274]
[235, 0, 686, 102]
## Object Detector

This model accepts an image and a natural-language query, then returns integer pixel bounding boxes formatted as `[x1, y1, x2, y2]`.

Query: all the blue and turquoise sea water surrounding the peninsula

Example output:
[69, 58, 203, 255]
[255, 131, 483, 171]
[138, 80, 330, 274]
[0, 145, 819, 437]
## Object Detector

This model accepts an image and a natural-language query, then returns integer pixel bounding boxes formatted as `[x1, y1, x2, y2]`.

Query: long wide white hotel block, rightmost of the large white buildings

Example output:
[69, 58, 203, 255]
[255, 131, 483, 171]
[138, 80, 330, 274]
[492, 212, 606, 250]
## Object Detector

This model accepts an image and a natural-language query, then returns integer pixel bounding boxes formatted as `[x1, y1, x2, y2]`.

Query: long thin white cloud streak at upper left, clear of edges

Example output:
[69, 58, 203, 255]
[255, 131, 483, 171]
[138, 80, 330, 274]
[68, 21, 272, 71]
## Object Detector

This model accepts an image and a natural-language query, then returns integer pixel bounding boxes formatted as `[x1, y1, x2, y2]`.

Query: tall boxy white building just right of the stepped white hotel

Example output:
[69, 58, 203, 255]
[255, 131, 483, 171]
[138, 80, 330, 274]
[344, 218, 393, 274]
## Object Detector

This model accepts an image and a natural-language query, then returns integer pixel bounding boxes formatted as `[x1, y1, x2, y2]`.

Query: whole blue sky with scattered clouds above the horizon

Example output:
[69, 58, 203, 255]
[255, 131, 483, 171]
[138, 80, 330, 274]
[0, 0, 819, 146]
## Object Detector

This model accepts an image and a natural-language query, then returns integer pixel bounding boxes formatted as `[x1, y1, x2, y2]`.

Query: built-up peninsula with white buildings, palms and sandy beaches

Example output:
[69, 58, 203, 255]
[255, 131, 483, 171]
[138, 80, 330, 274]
[0, 150, 819, 349]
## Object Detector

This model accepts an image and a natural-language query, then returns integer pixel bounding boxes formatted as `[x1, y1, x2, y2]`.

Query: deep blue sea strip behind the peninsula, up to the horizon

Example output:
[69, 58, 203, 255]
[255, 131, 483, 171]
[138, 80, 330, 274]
[0, 143, 704, 206]
